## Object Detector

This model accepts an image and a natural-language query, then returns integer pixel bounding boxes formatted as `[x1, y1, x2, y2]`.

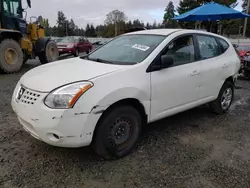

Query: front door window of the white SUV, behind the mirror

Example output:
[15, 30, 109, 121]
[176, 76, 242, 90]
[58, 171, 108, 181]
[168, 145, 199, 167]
[162, 35, 195, 66]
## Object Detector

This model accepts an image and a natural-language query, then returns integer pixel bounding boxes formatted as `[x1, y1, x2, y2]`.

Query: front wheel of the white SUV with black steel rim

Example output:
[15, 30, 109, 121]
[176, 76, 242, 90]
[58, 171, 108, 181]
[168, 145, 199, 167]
[92, 106, 142, 159]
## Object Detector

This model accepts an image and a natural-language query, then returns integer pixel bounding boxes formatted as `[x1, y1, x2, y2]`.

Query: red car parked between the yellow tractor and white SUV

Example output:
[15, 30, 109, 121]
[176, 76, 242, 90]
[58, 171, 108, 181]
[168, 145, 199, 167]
[57, 37, 92, 57]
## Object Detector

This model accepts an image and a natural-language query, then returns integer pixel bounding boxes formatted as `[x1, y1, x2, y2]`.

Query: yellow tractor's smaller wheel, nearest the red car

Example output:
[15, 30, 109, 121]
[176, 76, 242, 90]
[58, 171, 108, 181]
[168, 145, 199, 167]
[38, 40, 59, 64]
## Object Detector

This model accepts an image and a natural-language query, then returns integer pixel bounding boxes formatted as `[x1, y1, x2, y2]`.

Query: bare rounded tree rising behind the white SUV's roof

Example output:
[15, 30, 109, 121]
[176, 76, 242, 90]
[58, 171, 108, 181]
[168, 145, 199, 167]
[105, 10, 127, 36]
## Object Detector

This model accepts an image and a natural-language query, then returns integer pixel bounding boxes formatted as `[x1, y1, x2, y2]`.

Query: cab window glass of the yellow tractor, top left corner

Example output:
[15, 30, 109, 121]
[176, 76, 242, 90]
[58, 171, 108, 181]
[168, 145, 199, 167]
[3, 0, 22, 18]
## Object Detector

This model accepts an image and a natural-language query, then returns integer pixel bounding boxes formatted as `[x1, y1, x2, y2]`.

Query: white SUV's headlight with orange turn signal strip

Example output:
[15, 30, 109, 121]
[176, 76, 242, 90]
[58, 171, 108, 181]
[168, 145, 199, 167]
[44, 82, 93, 109]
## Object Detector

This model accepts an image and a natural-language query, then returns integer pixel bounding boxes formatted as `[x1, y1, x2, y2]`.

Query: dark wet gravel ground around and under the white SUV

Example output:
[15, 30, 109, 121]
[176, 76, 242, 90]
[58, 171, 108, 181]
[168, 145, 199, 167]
[0, 58, 250, 188]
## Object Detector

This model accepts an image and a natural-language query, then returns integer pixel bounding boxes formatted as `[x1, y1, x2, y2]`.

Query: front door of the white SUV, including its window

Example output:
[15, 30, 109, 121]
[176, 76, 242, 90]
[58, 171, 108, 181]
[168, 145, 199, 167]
[150, 35, 201, 121]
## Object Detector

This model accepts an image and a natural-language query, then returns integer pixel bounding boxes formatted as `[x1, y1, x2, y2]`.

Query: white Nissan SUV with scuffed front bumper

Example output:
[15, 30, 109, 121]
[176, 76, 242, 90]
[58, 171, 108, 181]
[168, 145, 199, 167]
[12, 29, 240, 159]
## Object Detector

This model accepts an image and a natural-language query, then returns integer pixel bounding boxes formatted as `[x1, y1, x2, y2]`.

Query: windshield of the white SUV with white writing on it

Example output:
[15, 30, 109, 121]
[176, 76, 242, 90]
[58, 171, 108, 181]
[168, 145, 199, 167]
[88, 34, 166, 65]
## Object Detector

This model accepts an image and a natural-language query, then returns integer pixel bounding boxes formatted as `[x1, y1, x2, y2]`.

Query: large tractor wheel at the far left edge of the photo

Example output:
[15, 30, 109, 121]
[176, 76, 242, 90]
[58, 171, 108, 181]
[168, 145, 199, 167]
[0, 39, 23, 73]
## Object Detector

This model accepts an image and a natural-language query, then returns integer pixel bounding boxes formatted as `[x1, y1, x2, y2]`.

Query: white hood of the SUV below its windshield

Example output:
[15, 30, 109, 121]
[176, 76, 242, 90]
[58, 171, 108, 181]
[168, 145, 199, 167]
[20, 57, 127, 92]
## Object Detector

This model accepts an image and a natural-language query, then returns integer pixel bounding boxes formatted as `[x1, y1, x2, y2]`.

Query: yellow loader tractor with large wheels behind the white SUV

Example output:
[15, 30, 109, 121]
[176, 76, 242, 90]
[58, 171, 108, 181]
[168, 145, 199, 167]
[0, 0, 59, 73]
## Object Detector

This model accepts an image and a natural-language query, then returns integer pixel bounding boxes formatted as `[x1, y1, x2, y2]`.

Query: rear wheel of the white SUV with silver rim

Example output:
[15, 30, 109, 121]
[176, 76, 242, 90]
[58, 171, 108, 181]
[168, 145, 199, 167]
[211, 81, 234, 114]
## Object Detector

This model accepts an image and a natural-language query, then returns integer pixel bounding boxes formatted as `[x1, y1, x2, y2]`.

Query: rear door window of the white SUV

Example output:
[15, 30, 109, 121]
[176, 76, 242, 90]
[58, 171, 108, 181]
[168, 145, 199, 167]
[197, 35, 221, 59]
